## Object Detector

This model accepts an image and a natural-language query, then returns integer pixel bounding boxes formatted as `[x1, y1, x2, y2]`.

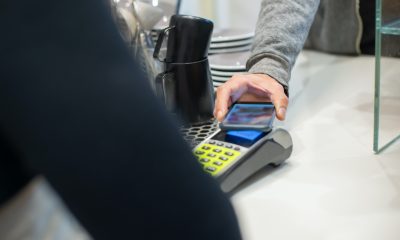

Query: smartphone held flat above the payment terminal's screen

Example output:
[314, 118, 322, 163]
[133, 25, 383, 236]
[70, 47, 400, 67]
[219, 102, 275, 132]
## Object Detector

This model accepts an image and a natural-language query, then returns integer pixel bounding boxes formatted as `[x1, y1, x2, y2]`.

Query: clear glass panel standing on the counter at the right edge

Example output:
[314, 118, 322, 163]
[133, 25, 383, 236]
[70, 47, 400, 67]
[374, 0, 400, 153]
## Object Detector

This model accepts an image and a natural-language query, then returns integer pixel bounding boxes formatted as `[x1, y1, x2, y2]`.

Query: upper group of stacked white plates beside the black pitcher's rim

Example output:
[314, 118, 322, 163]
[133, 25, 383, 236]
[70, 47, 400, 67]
[208, 28, 254, 54]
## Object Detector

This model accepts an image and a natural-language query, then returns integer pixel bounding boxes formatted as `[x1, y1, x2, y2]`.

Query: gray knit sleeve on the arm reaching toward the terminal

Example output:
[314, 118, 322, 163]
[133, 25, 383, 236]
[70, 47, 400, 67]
[247, 0, 319, 86]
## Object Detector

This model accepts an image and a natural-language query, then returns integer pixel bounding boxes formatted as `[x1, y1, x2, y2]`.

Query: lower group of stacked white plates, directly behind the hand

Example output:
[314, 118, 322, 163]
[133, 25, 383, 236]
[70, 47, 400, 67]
[208, 51, 250, 88]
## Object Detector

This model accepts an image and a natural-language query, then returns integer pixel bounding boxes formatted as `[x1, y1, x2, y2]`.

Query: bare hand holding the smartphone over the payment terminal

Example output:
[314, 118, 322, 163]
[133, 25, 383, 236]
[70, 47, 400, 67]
[214, 74, 289, 122]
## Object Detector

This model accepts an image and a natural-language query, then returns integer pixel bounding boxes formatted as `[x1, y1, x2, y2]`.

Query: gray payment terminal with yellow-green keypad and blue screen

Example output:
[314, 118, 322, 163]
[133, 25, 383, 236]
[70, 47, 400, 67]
[193, 129, 293, 192]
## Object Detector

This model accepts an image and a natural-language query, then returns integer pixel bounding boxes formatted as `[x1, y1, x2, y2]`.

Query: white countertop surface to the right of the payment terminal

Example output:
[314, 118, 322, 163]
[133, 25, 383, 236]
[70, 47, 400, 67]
[232, 51, 400, 240]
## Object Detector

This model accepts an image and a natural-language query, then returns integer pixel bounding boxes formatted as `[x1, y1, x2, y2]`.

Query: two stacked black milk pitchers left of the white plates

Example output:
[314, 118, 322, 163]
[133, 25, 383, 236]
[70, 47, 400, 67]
[153, 15, 214, 124]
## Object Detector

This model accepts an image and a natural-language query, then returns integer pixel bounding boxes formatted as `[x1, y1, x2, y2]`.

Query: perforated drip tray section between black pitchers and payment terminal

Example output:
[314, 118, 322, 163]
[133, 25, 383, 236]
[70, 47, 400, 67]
[181, 120, 218, 148]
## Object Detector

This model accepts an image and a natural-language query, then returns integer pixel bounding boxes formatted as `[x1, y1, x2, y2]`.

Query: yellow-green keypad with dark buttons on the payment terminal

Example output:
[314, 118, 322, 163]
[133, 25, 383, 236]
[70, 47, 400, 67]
[194, 142, 240, 176]
